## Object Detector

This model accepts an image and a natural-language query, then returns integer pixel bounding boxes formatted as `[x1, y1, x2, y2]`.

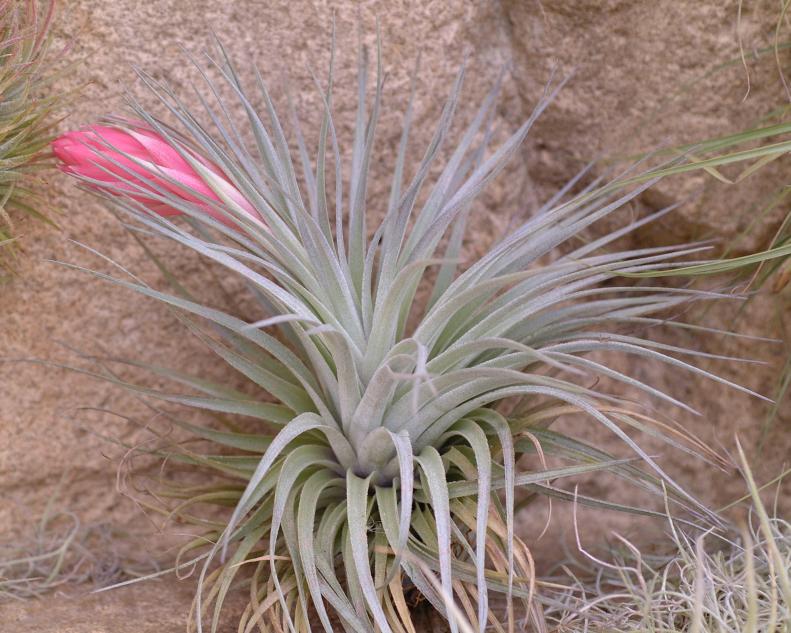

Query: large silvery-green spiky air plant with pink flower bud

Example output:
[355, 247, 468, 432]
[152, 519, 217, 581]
[54, 33, 784, 633]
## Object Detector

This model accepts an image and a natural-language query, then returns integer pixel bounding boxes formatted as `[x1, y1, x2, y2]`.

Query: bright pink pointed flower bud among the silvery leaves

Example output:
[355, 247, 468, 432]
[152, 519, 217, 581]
[52, 124, 259, 228]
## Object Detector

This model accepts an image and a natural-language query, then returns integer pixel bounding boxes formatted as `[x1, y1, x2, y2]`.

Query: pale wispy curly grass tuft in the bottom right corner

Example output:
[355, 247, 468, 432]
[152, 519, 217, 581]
[543, 449, 791, 633]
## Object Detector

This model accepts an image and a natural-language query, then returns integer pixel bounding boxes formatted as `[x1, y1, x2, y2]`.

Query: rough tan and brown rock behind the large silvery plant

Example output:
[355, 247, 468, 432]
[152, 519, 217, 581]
[0, 0, 791, 633]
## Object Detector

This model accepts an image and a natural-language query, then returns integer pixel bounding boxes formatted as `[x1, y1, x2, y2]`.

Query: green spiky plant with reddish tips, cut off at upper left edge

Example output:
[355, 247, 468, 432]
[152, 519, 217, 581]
[0, 0, 60, 254]
